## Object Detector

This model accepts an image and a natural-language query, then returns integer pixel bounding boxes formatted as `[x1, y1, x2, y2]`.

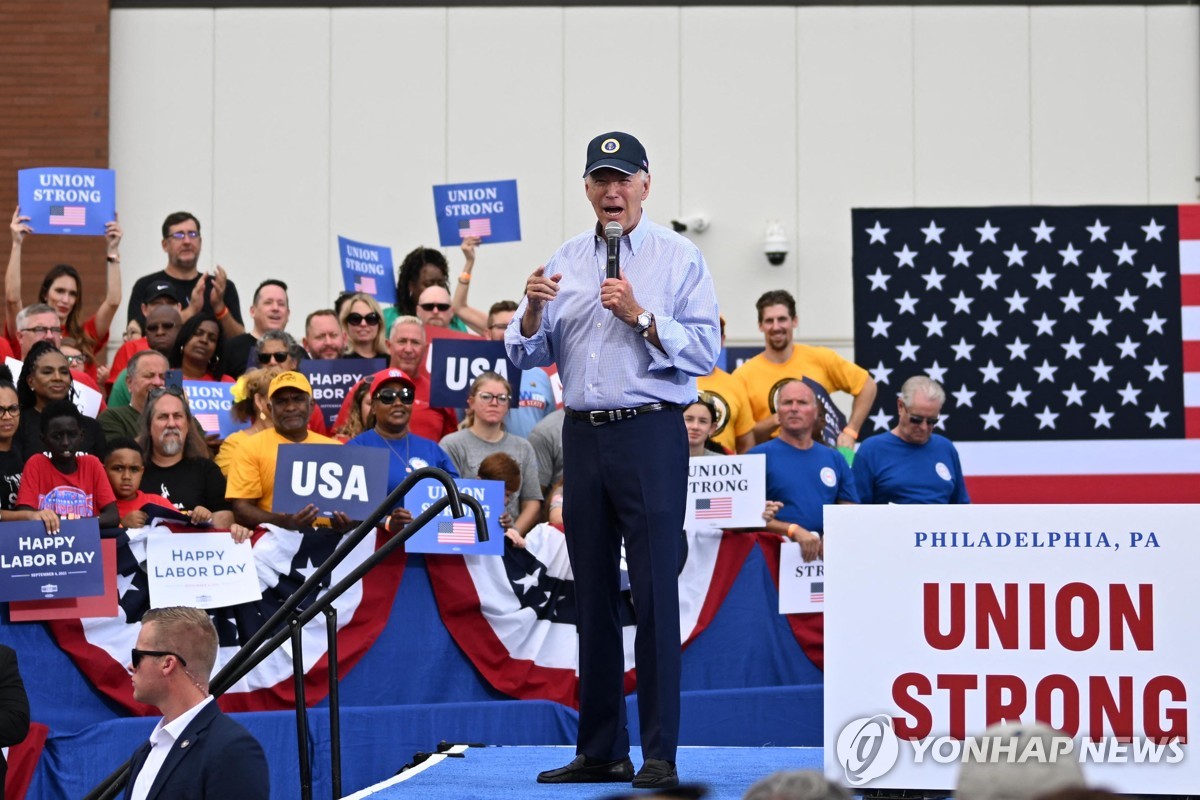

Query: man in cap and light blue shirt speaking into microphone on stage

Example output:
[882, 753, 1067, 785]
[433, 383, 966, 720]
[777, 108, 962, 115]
[504, 132, 720, 788]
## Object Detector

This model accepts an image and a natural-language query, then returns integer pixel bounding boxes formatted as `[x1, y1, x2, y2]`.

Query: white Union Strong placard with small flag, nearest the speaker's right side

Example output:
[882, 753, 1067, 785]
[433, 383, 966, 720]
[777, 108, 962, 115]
[684, 453, 767, 530]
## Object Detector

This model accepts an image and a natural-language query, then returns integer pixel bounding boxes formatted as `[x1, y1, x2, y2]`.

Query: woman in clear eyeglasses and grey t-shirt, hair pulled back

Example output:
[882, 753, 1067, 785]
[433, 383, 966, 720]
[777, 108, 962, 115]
[440, 372, 541, 536]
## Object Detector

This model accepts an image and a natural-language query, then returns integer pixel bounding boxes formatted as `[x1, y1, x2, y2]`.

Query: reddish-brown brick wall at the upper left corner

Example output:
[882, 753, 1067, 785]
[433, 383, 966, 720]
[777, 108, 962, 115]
[0, 0, 109, 347]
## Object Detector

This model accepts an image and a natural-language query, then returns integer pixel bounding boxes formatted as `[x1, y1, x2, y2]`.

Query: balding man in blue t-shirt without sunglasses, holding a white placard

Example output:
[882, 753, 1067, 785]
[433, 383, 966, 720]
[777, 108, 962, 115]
[750, 379, 858, 561]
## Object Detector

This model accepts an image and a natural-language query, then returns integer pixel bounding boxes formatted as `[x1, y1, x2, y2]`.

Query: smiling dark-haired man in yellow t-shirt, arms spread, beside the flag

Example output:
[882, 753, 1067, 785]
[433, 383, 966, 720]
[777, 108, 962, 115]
[733, 289, 877, 447]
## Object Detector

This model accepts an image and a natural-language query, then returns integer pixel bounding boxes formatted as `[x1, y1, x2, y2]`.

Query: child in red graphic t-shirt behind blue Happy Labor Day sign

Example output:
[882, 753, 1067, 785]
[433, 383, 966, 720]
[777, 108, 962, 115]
[17, 399, 119, 533]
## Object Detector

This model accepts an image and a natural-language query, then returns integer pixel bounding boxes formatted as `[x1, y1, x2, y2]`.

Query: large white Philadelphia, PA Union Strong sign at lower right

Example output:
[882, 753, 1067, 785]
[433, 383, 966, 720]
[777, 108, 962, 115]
[824, 505, 1200, 794]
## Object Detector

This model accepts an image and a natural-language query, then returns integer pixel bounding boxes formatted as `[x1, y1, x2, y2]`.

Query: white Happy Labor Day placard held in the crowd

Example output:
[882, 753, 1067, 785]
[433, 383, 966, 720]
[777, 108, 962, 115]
[146, 528, 263, 608]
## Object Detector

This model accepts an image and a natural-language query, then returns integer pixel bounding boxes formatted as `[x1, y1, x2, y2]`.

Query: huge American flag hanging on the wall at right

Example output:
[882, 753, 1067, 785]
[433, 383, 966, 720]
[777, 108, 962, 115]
[852, 206, 1200, 503]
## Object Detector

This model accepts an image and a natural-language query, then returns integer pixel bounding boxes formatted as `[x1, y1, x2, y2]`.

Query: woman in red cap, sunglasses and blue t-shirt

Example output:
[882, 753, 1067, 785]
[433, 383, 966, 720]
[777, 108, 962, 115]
[346, 368, 458, 534]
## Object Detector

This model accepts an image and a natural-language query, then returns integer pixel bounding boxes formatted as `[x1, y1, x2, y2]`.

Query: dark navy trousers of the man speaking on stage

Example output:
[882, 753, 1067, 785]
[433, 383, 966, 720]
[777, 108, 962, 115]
[563, 409, 688, 762]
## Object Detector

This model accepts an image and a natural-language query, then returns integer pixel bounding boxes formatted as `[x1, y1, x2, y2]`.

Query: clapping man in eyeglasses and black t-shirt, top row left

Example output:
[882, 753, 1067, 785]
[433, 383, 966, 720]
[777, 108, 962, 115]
[126, 211, 246, 341]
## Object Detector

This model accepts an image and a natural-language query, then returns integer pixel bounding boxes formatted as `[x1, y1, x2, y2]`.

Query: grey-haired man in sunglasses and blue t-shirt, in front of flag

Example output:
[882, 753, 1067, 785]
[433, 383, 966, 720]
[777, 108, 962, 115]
[854, 375, 971, 504]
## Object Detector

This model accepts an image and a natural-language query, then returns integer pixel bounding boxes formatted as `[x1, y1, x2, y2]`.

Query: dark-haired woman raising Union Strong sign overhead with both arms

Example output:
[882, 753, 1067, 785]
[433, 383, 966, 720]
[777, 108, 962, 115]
[5, 206, 121, 381]
